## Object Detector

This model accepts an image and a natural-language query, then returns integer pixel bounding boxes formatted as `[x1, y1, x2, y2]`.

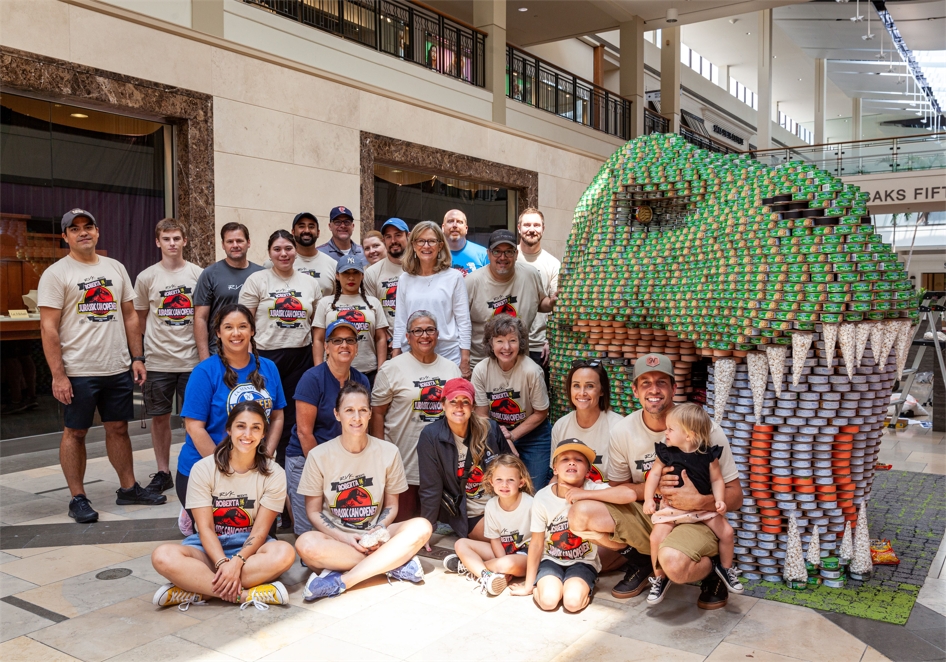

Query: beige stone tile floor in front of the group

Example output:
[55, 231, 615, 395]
[0, 426, 946, 662]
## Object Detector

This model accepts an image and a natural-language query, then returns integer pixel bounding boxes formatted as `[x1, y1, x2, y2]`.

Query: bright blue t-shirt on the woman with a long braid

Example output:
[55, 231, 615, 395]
[177, 354, 286, 476]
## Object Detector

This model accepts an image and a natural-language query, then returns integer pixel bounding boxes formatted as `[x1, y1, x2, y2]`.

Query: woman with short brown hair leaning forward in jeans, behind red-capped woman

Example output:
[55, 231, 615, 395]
[473, 313, 552, 491]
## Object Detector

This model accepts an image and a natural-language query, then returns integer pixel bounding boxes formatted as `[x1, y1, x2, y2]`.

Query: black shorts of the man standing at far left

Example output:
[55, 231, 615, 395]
[63, 371, 135, 430]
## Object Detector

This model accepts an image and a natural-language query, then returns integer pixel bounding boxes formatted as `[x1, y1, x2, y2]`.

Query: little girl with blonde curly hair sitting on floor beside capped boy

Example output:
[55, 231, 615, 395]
[443, 455, 533, 595]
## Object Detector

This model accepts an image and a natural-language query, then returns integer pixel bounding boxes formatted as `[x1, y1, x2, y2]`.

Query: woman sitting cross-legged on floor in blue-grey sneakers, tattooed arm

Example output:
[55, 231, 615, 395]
[296, 383, 432, 600]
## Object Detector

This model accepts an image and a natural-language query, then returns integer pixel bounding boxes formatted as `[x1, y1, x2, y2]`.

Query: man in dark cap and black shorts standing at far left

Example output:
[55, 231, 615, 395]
[37, 209, 167, 523]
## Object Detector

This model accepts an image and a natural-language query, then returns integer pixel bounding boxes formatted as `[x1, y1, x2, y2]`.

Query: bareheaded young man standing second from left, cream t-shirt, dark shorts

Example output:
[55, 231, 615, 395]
[135, 218, 203, 494]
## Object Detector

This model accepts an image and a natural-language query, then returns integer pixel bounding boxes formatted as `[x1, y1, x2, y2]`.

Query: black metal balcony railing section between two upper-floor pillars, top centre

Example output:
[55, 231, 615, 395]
[506, 45, 631, 140]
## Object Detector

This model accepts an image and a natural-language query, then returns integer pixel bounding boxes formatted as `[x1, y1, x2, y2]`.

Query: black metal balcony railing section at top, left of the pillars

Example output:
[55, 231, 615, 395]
[243, 0, 486, 87]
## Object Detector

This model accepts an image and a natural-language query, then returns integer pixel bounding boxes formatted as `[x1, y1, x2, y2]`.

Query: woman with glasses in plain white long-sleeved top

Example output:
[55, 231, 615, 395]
[391, 221, 472, 379]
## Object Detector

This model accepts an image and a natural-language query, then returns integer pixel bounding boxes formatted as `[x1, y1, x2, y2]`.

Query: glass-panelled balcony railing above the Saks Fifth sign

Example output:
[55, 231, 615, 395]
[748, 133, 946, 177]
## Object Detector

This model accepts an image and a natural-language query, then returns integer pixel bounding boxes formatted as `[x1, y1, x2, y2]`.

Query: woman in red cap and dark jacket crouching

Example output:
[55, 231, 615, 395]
[417, 378, 512, 541]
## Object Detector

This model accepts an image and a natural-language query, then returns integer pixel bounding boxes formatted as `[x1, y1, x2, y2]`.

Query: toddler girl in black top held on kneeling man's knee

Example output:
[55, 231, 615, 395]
[644, 402, 743, 605]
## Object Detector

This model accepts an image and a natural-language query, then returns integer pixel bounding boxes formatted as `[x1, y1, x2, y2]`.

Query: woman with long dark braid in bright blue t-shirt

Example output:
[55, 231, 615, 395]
[174, 304, 286, 508]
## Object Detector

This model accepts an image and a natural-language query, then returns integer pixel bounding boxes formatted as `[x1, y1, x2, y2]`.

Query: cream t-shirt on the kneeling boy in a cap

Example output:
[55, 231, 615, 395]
[530, 480, 608, 571]
